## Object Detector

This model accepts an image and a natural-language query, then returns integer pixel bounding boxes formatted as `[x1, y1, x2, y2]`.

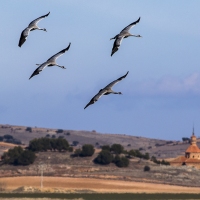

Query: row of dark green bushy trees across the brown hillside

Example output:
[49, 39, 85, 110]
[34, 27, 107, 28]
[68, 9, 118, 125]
[2, 137, 169, 167]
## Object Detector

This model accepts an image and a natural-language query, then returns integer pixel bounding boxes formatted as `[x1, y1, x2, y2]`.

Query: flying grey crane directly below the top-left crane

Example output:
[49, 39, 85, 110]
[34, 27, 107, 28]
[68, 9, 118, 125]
[29, 43, 71, 79]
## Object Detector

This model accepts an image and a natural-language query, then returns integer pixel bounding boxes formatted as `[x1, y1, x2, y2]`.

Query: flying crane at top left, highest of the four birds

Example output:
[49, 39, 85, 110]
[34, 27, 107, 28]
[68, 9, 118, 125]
[18, 12, 50, 47]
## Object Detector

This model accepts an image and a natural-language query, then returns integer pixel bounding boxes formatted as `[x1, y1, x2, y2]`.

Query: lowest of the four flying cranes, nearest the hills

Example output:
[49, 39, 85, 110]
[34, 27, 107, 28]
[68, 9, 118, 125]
[84, 72, 129, 109]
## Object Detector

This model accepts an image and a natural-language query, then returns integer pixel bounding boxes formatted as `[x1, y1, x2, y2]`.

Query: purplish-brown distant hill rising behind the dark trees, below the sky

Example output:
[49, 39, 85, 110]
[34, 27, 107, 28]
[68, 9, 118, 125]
[0, 124, 195, 159]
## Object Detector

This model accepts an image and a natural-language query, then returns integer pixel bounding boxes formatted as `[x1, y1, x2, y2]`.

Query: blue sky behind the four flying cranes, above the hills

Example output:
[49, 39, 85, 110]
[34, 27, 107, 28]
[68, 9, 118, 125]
[0, 0, 200, 140]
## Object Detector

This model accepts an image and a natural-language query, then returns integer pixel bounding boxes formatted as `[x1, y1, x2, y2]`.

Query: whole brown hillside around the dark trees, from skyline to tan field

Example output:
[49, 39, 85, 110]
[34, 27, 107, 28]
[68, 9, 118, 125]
[0, 122, 200, 190]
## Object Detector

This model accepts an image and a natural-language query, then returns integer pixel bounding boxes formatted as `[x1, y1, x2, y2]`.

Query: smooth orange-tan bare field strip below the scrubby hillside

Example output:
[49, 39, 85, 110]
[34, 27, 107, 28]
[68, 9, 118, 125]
[0, 176, 200, 193]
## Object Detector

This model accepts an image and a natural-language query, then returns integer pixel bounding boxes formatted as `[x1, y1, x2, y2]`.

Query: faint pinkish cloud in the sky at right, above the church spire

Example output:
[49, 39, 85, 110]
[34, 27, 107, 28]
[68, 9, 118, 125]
[133, 73, 200, 96]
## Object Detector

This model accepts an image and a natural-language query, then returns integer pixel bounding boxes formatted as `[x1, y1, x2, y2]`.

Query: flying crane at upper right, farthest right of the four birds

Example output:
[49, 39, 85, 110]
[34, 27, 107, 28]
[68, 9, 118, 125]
[110, 17, 142, 56]
